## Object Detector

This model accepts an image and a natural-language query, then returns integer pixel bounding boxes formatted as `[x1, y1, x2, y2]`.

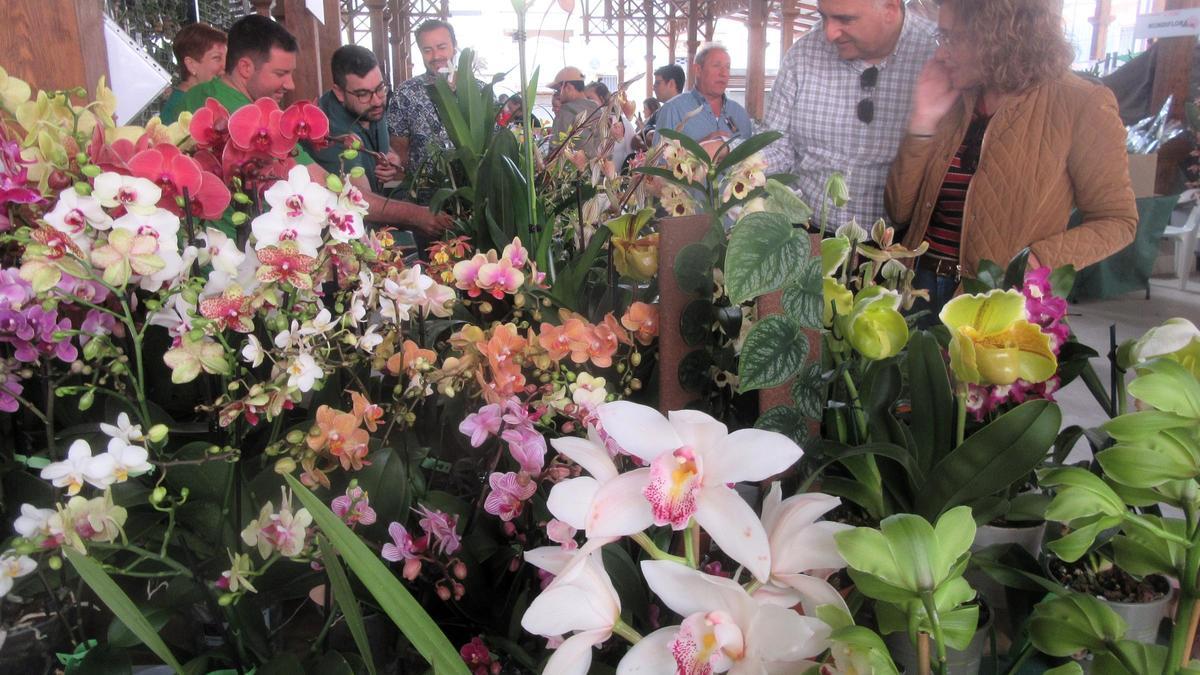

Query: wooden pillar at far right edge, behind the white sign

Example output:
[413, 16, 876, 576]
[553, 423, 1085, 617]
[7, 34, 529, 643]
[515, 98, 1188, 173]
[1150, 0, 1200, 195]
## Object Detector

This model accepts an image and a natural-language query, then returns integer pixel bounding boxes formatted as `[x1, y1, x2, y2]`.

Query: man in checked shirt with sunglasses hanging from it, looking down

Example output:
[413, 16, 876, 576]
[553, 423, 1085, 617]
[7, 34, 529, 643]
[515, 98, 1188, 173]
[763, 0, 936, 227]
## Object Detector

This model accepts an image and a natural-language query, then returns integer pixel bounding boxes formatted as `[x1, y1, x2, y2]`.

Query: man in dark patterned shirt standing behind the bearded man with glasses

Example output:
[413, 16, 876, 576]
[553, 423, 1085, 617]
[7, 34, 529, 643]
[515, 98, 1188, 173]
[388, 19, 458, 183]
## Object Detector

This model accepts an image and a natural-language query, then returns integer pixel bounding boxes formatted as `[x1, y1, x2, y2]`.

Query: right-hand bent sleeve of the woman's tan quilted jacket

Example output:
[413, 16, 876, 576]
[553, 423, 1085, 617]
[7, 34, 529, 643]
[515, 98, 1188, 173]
[1031, 86, 1138, 269]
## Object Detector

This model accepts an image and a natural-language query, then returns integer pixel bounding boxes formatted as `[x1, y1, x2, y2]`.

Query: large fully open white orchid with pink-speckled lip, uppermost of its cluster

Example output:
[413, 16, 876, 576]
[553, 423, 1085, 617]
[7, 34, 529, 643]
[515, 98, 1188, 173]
[595, 401, 803, 581]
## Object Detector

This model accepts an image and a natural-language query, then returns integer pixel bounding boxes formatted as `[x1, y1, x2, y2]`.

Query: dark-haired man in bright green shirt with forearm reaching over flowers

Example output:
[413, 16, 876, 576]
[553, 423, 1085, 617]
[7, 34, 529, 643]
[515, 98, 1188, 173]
[184, 14, 452, 237]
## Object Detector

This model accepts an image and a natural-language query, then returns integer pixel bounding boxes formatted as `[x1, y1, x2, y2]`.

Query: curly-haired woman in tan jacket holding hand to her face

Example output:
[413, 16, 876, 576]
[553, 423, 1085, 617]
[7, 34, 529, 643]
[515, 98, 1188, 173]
[886, 0, 1138, 318]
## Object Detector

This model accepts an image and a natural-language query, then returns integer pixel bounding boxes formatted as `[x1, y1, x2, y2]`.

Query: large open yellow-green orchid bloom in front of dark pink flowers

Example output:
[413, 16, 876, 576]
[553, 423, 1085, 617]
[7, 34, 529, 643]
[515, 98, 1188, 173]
[940, 291, 1058, 386]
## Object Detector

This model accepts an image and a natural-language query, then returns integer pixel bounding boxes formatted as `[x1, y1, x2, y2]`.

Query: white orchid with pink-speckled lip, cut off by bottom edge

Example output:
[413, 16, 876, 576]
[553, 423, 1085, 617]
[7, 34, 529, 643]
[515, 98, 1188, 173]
[617, 561, 832, 675]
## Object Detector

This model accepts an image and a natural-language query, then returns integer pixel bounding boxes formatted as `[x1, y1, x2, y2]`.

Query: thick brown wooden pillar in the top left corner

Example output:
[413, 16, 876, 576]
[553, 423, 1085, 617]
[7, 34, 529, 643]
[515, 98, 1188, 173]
[0, 0, 112, 98]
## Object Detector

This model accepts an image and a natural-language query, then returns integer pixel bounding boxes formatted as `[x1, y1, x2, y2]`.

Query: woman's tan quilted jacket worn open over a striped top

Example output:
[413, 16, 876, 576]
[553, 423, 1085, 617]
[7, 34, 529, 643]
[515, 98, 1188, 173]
[884, 74, 1138, 276]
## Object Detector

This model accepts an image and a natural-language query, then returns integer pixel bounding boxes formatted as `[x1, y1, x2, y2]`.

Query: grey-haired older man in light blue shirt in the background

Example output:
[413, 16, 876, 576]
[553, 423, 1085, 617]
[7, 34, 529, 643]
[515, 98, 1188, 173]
[656, 43, 754, 145]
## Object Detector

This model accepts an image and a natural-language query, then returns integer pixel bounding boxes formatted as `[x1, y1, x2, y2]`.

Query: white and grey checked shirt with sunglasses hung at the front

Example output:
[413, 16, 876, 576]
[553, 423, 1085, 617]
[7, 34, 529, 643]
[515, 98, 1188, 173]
[763, 12, 936, 228]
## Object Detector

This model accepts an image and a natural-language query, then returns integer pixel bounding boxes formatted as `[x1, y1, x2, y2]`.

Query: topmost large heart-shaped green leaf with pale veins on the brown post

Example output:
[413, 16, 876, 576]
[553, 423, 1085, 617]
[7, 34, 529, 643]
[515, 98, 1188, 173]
[725, 211, 809, 304]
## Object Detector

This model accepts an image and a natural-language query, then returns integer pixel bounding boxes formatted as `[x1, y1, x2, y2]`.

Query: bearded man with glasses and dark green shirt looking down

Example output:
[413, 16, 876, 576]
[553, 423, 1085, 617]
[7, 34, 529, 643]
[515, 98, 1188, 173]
[305, 44, 400, 195]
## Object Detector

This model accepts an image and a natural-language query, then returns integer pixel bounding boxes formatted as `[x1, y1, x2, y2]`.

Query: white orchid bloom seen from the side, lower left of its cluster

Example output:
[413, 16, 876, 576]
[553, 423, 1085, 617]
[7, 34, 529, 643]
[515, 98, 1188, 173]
[521, 546, 620, 675]
